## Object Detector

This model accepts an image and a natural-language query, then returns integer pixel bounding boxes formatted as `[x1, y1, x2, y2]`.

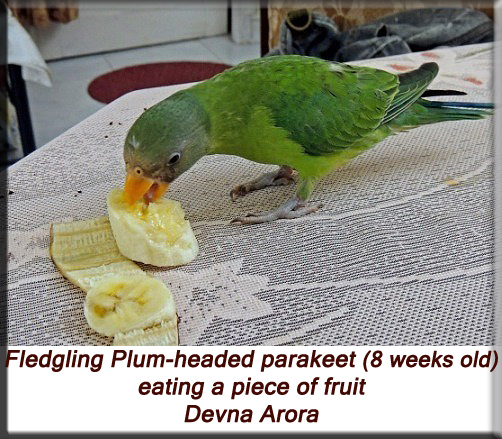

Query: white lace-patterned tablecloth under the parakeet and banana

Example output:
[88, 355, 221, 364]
[4, 44, 494, 345]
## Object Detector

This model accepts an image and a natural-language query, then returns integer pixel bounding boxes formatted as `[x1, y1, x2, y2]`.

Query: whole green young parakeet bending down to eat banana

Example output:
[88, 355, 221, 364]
[124, 55, 493, 223]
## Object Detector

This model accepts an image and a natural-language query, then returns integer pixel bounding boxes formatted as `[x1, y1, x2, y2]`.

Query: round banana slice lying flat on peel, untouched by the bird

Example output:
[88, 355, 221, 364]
[84, 275, 176, 336]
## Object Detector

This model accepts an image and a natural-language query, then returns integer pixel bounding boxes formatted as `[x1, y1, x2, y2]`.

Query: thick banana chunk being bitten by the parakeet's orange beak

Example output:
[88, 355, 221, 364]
[107, 189, 199, 267]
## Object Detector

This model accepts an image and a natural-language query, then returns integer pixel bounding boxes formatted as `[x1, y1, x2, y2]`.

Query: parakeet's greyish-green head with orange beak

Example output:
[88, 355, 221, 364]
[124, 91, 209, 204]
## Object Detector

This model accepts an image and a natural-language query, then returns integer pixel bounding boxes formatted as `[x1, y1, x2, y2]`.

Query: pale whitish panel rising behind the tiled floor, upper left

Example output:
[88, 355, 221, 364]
[30, 0, 227, 60]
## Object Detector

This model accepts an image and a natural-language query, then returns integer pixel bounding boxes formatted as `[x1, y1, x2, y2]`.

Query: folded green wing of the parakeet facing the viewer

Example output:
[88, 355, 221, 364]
[267, 62, 399, 155]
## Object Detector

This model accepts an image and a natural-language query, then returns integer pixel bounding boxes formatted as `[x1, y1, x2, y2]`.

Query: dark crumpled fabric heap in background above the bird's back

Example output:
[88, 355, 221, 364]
[268, 8, 494, 62]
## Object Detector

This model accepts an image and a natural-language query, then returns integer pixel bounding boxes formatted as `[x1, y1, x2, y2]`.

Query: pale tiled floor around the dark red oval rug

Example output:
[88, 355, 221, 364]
[27, 35, 260, 147]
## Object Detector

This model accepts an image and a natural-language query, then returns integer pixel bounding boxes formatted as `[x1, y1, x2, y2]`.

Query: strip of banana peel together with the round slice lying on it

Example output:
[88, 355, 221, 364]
[49, 216, 178, 346]
